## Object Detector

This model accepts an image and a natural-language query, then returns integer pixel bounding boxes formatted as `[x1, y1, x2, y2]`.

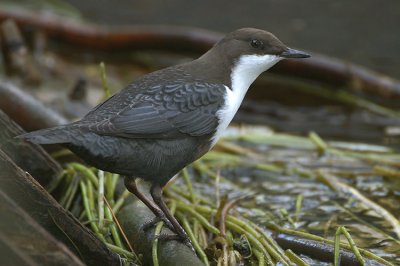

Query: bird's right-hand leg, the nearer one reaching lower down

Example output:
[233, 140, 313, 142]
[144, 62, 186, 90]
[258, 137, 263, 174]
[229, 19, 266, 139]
[150, 184, 194, 250]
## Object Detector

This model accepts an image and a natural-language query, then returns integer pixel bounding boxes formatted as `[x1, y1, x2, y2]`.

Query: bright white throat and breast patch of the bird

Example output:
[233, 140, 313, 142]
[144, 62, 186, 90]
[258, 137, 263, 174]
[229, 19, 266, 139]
[211, 55, 282, 147]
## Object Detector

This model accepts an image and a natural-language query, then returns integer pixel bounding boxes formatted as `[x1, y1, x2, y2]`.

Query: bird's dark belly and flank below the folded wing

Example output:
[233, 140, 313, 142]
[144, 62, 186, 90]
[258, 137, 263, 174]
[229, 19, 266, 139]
[66, 133, 210, 185]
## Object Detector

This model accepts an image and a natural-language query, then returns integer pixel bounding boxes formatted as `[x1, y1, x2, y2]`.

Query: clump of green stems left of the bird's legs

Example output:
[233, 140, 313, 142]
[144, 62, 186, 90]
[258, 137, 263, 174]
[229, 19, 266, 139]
[49, 162, 140, 265]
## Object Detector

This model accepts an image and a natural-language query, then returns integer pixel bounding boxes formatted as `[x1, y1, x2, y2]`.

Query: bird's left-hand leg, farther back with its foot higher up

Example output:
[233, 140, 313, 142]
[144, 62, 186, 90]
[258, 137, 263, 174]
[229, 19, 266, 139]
[124, 177, 175, 231]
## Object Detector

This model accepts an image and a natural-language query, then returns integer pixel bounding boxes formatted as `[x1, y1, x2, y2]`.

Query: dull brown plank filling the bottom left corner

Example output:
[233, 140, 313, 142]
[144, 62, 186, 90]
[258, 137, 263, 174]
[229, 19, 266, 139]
[0, 189, 84, 266]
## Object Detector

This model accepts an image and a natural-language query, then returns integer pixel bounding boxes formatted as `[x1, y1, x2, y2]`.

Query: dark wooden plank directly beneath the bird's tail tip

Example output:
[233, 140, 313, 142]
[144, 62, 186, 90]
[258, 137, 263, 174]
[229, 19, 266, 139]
[0, 110, 62, 186]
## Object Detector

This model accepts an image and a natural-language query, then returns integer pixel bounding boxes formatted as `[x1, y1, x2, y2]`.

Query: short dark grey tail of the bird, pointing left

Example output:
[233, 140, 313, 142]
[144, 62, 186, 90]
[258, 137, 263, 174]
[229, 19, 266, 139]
[16, 125, 75, 144]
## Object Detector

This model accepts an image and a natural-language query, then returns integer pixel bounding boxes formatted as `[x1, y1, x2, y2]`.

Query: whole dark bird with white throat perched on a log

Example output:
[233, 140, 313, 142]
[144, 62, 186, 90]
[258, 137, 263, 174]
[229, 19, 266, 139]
[20, 28, 309, 248]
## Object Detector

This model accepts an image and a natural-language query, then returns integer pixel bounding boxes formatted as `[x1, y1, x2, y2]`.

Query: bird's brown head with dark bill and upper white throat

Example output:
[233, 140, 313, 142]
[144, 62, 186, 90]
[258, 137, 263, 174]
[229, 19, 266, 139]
[200, 28, 310, 90]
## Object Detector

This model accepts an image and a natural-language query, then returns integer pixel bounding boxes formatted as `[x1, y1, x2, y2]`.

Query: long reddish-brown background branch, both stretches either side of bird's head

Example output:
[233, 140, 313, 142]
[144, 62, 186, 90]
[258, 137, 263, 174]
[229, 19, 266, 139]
[0, 11, 400, 99]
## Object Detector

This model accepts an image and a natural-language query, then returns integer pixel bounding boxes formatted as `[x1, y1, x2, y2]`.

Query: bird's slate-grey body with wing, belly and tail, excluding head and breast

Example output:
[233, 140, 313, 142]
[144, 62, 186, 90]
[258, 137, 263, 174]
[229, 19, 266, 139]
[20, 61, 226, 182]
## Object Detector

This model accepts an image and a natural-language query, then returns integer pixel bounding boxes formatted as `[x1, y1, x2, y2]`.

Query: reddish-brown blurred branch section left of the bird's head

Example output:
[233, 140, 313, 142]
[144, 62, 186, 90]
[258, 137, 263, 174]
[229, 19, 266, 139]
[0, 10, 219, 53]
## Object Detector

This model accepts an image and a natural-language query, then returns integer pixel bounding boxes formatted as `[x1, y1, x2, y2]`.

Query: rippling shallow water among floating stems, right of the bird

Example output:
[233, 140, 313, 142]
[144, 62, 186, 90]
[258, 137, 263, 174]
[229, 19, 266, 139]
[192, 138, 400, 265]
